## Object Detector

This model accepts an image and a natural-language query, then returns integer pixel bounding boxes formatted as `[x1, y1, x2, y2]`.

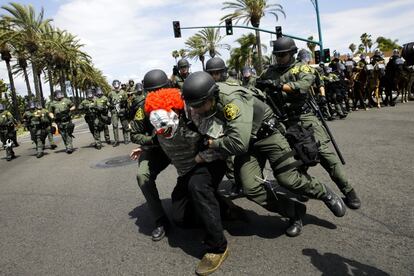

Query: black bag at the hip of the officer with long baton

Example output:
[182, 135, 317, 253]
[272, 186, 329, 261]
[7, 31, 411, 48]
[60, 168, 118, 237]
[285, 124, 320, 167]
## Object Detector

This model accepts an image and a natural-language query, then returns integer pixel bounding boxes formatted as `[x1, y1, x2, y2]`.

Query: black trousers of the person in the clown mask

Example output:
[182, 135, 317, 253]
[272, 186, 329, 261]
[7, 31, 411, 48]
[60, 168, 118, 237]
[171, 160, 227, 253]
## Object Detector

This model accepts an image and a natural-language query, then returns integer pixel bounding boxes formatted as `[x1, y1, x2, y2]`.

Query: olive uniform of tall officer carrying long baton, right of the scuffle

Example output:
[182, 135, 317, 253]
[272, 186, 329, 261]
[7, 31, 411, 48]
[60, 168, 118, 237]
[261, 62, 353, 194]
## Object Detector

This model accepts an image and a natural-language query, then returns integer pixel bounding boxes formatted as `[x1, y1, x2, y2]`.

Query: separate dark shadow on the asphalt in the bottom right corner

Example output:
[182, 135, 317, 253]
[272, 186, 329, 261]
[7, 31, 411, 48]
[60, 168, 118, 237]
[302, 248, 389, 276]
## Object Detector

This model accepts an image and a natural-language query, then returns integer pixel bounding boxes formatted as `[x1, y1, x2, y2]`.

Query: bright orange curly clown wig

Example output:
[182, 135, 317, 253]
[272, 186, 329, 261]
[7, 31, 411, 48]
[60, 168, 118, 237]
[144, 88, 184, 114]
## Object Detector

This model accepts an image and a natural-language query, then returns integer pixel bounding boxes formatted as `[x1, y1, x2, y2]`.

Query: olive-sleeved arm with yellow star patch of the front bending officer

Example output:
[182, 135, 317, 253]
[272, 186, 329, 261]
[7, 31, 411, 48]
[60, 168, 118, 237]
[209, 98, 253, 155]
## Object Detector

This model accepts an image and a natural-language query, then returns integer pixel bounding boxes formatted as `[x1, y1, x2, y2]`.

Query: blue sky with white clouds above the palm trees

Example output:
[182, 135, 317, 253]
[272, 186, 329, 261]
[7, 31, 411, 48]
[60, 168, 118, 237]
[0, 0, 414, 95]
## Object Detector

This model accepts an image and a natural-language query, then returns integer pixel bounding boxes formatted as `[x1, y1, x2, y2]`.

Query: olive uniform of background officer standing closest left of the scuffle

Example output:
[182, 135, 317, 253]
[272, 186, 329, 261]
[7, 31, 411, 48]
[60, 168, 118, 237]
[108, 90, 130, 143]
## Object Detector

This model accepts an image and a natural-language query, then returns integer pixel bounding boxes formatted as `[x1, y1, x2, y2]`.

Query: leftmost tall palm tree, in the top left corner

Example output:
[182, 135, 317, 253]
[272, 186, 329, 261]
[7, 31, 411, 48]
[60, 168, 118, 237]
[2, 3, 52, 102]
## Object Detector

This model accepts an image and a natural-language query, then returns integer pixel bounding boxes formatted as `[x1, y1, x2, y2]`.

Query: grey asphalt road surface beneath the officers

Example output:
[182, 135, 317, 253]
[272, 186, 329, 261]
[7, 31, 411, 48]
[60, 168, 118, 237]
[0, 102, 414, 276]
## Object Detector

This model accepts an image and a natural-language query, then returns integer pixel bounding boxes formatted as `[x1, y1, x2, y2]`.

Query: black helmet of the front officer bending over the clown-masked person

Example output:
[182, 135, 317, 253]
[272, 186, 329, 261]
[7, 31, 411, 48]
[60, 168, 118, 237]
[182, 71, 218, 107]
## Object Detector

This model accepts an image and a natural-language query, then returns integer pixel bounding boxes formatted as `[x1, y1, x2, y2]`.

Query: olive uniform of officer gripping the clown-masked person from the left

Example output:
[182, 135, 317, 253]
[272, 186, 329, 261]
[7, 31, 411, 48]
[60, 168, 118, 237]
[131, 96, 170, 226]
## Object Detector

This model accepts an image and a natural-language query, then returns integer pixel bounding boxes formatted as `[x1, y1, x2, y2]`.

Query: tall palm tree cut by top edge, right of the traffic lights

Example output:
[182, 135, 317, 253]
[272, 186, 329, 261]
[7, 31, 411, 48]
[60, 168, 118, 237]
[221, 0, 286, 74]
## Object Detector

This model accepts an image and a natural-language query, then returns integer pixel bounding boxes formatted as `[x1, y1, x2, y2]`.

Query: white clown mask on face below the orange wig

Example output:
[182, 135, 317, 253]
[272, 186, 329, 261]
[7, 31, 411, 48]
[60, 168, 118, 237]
[150, 109, 180, 139]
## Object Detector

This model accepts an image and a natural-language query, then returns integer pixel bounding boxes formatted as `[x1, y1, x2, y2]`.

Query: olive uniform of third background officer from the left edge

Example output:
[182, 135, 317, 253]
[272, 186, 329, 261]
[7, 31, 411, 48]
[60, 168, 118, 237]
[49, 98, 75, 150]
